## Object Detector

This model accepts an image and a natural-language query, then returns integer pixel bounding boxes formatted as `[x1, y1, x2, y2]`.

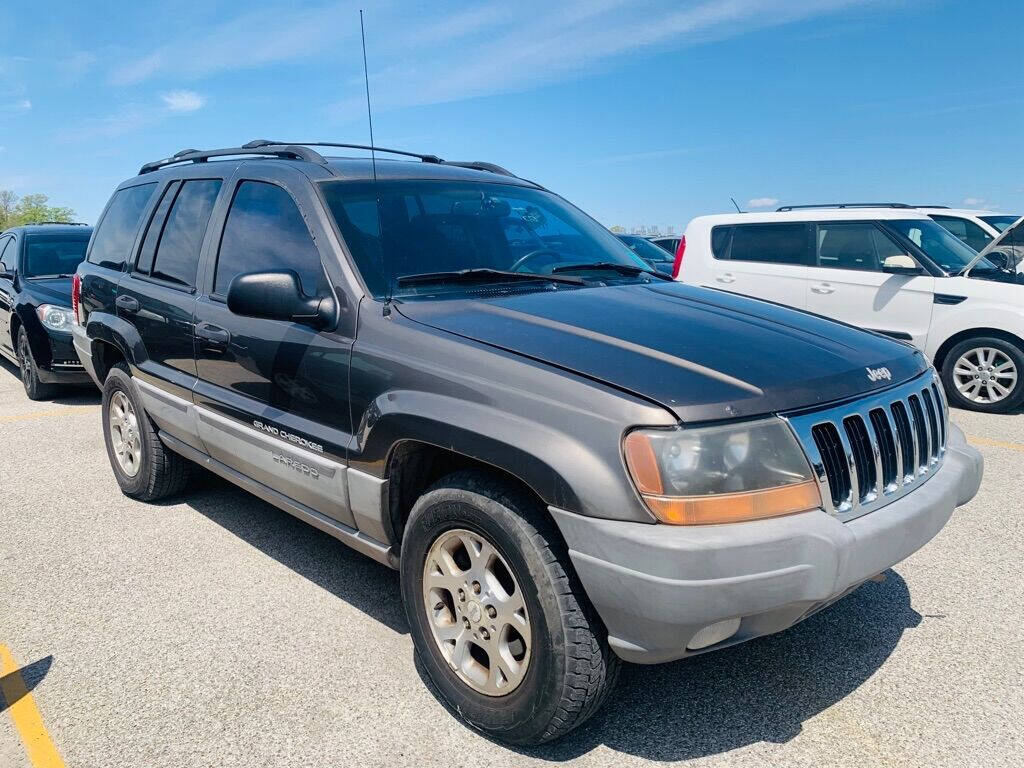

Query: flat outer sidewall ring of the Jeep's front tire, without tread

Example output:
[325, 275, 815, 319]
[401, 487, 565, 741]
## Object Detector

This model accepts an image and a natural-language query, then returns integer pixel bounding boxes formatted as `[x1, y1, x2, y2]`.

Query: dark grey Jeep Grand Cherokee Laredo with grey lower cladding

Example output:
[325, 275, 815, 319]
[75, 141, 982, 743]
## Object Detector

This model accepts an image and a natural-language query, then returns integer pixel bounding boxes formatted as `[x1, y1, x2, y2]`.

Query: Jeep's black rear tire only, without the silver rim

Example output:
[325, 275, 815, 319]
[101, 362, 193, 502]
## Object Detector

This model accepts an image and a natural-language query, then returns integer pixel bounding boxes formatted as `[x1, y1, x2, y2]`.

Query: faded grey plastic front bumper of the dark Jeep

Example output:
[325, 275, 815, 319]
[551, 425, 983, 664]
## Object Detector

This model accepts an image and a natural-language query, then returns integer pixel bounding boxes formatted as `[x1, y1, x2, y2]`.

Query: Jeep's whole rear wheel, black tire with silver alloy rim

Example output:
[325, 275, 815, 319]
[102, 362, 191, 502]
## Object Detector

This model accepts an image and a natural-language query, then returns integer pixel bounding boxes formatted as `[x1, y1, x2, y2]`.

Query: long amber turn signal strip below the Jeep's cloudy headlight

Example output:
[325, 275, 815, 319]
[638, 480, 821, 525]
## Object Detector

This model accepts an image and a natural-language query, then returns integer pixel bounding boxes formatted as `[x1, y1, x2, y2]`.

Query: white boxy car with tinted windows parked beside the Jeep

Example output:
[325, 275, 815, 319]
[675, 206, 1024, 412]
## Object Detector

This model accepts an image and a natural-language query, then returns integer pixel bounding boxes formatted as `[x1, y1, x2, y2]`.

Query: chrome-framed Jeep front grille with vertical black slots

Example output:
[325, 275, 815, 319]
[783, 371, 949, 521]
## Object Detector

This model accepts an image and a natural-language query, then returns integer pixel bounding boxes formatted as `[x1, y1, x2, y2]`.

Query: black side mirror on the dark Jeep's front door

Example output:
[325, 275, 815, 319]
[227, 269, 337, 329]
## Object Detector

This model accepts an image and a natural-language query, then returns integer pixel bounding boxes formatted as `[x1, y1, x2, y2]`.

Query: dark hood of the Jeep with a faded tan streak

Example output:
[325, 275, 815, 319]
[398, 283, 928, 422]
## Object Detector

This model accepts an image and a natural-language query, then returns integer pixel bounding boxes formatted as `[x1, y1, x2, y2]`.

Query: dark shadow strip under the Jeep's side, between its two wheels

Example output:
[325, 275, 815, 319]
[180, 479, 409, 635]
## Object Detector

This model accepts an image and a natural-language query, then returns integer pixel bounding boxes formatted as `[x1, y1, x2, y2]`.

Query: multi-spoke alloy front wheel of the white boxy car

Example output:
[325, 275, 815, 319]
[942, 337, 1024, 413]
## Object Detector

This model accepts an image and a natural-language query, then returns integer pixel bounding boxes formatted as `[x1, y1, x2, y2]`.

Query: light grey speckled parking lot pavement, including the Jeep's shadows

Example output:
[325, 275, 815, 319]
[0, 365, 1024, 768]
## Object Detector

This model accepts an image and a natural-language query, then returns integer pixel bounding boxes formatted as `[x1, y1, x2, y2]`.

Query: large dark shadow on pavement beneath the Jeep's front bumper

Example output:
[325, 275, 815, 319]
[521, 570, 922, 761]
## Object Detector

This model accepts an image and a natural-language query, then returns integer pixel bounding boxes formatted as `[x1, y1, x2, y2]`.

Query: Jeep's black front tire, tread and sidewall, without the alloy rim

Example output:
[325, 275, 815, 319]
[401, 471, 621, 745]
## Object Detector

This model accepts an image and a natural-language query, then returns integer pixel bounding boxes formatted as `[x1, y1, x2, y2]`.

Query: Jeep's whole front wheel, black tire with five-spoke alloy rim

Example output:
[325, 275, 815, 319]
[401, 472, 620, 744]
